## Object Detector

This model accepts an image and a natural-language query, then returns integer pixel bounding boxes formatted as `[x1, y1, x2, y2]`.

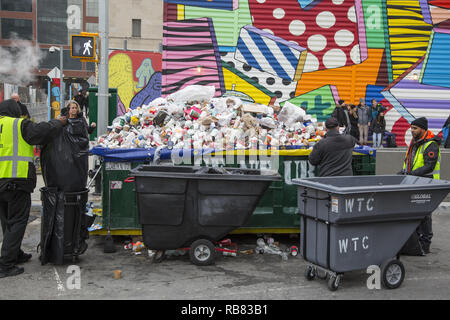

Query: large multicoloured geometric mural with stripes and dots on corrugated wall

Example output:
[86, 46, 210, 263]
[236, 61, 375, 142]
[163, 0, 450, 146]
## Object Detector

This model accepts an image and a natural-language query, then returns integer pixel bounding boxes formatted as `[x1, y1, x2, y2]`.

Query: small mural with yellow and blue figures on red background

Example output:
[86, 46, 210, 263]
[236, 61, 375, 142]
[109, 50, 162, 115]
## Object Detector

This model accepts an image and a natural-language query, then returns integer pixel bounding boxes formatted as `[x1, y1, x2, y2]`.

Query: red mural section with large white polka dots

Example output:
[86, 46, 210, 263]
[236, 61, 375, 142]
[249, 0, 367, 73]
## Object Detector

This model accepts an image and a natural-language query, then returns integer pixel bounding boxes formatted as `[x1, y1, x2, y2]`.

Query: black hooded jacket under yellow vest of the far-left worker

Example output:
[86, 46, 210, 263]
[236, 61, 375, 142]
[0, 99, 63, 193]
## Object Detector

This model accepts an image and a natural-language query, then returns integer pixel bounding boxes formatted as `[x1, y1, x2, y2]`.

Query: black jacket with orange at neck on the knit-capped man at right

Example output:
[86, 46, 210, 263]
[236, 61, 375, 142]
[405, 130, 441, 178]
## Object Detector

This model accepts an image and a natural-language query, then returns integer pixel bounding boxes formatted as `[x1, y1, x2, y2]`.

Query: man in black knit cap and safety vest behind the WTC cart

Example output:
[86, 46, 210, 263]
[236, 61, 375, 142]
[400, 117, 441, 253]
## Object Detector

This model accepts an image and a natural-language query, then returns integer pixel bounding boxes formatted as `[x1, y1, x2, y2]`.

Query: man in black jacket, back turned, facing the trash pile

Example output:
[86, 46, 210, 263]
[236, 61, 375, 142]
[309, 118, 356, 177]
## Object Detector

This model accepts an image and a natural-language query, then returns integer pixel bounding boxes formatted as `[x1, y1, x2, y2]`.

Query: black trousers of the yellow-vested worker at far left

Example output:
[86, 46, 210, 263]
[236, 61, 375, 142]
[0, 190, 31, 268]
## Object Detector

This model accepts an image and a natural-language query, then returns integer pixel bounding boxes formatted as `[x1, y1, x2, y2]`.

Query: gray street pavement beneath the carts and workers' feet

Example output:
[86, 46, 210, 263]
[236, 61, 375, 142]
[0, 174, 450, 301]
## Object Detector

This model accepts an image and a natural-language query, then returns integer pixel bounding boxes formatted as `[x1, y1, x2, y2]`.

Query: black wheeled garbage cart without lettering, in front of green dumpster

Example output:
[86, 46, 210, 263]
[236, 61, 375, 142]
[130, 165, 281, 265]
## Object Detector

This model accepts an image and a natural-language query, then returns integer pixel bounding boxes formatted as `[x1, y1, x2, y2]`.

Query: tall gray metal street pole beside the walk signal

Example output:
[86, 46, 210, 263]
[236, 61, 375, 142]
[97, 0, 109, 136]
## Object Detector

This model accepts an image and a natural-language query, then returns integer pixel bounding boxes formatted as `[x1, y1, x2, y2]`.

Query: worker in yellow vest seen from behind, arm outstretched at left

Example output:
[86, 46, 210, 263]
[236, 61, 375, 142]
[0, 99, 67, 278]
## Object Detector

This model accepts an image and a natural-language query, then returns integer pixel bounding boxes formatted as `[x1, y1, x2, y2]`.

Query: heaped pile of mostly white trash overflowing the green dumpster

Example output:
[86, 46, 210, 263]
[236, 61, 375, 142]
[97, 85, 324, 150]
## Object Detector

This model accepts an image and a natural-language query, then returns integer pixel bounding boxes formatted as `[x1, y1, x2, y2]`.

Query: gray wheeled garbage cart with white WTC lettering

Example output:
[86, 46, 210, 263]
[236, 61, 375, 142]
[293, 175, 450, 291]
